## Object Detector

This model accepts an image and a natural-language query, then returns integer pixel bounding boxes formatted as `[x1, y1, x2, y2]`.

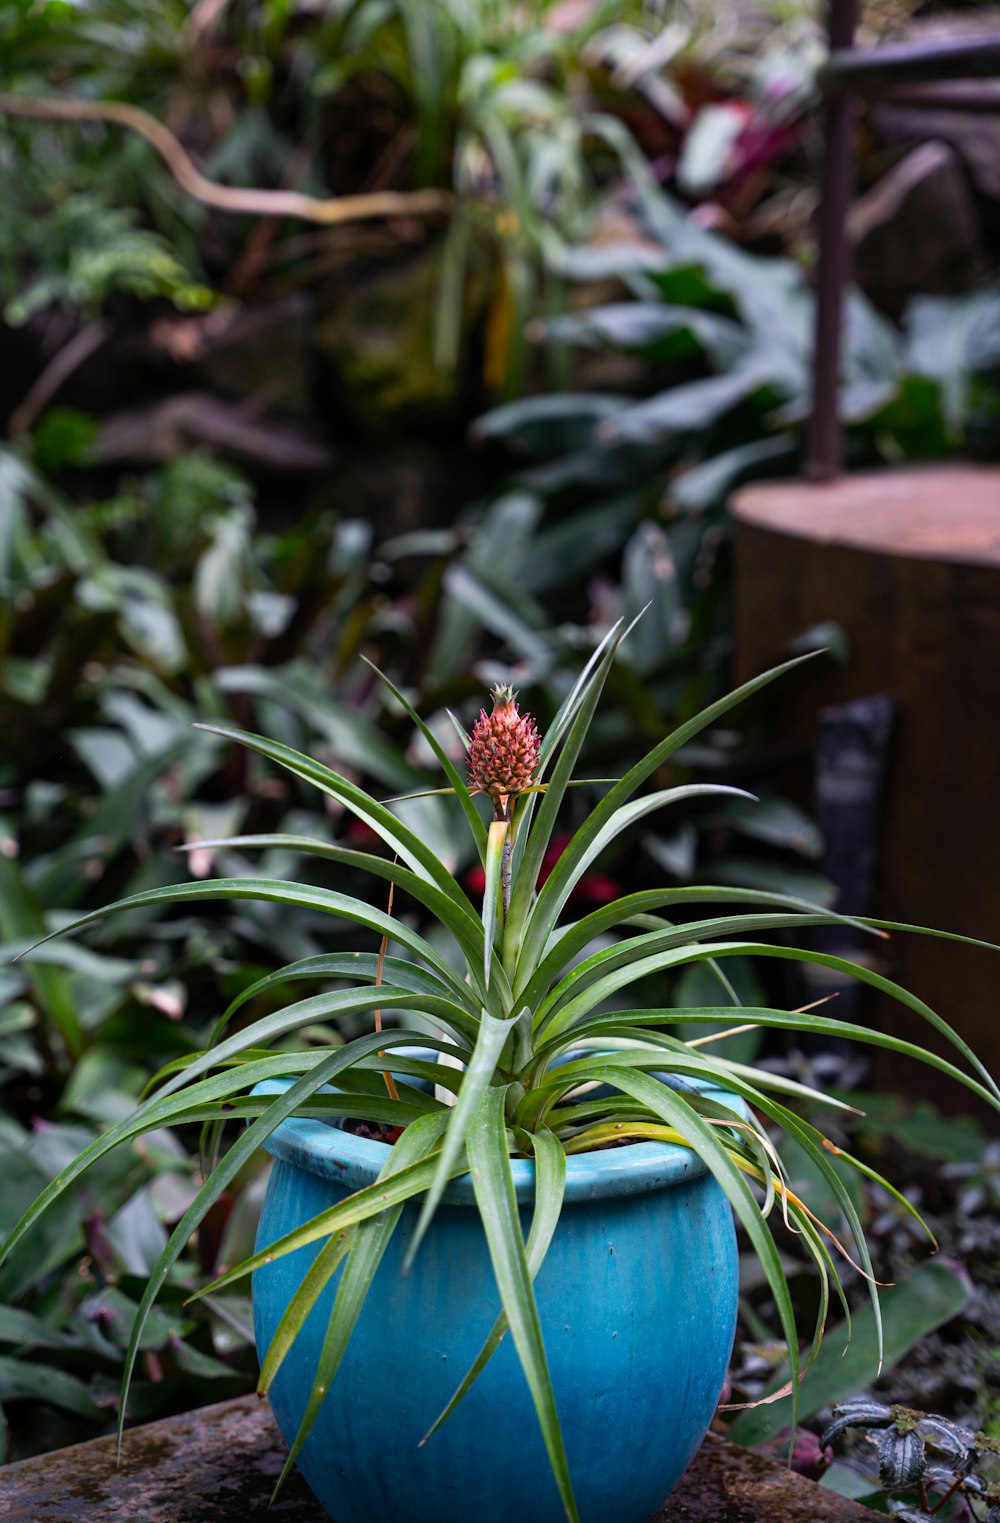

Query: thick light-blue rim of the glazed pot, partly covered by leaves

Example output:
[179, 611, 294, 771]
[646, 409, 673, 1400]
[253, 1078, 746, 1206]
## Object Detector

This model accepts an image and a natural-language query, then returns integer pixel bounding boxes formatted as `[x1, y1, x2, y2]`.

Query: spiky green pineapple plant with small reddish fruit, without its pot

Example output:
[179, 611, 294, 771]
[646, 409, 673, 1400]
[2, 626, 1000, 1520]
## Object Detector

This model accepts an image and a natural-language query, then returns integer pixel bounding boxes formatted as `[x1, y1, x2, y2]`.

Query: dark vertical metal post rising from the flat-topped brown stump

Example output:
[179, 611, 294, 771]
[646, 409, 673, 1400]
[805, 0, 857, 481]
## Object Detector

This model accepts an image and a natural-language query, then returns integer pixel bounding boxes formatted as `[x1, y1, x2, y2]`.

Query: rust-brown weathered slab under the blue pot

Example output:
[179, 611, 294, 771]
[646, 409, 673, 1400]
[0, 1397, 884, 1523]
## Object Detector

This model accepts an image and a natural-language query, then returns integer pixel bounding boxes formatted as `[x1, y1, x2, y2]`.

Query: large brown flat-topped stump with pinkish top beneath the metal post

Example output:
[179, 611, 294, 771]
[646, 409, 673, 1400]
[732, 465, 1000, 1109]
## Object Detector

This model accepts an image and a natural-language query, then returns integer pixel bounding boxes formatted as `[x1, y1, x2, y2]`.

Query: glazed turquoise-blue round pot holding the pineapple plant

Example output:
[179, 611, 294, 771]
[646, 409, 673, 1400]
[253, 1083, 737, 1523]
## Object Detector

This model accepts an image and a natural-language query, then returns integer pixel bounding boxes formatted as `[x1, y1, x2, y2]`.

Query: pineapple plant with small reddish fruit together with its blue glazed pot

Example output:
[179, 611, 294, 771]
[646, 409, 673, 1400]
[5, 626, 1000, 1523]
